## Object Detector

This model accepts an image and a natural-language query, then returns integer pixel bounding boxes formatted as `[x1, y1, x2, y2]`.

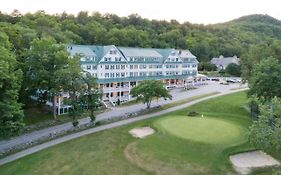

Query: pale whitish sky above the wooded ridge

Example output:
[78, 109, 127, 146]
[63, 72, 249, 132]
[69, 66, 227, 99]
[0, 0, 281, 24]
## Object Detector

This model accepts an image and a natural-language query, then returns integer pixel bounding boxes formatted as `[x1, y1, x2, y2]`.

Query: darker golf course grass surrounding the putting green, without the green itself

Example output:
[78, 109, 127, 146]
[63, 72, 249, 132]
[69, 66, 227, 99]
[0, 93, 262, 175]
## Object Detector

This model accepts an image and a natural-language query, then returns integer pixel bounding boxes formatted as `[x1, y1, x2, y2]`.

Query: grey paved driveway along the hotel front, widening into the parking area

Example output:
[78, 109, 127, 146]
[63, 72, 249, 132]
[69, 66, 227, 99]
[0, 82, 245, 152]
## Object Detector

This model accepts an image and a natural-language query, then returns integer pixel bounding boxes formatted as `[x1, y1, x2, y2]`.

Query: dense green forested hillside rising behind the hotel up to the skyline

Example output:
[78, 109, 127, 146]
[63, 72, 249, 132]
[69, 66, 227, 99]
[0, 11, 281, 61]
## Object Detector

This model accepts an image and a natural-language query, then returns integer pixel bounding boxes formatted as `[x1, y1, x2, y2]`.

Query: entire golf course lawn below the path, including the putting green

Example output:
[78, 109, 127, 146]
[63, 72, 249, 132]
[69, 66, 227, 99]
[0, 92, 274, 175]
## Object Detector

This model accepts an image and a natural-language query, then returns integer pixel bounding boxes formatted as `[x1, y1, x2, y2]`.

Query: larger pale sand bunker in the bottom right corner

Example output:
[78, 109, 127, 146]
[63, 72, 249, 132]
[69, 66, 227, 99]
[230, 151, 280, 174]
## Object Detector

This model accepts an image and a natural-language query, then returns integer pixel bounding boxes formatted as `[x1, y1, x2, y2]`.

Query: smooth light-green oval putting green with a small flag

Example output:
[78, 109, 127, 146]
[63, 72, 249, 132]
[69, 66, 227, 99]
[157, 116, 243, 144]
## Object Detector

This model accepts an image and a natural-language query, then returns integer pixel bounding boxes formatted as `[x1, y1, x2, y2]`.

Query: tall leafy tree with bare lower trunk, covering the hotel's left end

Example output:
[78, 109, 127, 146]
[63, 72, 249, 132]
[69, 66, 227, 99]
[25, 38, 71, 119]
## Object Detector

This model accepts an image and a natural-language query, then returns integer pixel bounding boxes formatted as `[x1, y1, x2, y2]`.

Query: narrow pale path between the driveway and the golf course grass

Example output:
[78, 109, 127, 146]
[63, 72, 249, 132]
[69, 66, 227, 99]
[0, 89, 245, 165]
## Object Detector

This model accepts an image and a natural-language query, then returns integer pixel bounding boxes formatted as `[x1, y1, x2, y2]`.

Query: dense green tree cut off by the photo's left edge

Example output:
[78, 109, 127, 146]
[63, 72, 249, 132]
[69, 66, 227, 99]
[0, 32, 24, 137]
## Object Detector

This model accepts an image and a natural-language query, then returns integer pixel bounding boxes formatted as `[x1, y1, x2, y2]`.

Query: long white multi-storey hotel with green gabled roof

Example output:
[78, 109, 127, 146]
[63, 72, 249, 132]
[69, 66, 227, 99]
[68, 45, 198, 105]
